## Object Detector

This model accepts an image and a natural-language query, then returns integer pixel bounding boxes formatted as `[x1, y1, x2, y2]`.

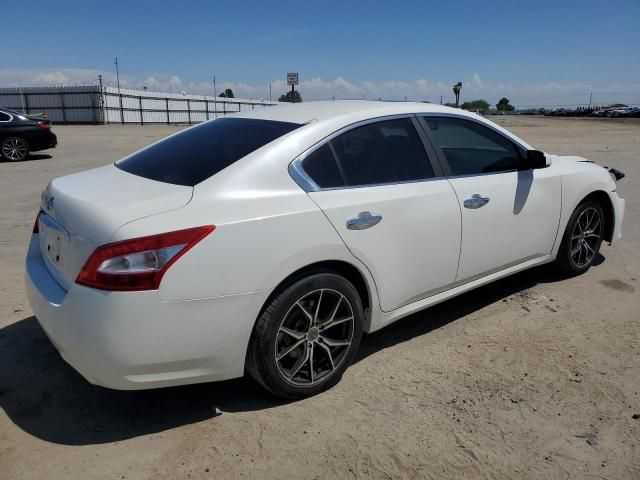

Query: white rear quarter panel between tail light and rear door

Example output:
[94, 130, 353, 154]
[114, 173, 372, 301]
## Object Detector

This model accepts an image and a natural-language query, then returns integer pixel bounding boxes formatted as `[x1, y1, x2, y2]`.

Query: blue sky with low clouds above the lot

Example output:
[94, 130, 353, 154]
[0, 0, 640, 105]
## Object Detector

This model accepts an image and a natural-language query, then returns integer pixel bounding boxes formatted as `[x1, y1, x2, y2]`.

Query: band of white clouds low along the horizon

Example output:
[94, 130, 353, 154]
[0, 68, 640, 106]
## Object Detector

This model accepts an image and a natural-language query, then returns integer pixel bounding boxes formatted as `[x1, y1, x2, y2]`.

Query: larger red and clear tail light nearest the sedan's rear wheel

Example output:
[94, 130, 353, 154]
[76, 225, 215, 291]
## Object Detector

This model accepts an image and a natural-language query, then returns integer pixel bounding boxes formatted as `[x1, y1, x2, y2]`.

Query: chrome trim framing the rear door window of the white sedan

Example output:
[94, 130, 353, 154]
[288, 113, 444, 193]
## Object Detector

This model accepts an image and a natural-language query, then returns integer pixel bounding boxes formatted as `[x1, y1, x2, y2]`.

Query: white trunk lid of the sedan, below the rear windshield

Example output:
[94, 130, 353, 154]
[39, 165, 193, 290]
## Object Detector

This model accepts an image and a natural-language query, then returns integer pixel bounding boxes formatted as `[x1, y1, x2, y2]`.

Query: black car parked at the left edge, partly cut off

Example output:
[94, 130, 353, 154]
[0, 108, 58, 161]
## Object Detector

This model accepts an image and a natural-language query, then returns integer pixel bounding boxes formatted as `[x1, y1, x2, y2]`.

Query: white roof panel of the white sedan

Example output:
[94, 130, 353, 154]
[233, 100, 476, 124]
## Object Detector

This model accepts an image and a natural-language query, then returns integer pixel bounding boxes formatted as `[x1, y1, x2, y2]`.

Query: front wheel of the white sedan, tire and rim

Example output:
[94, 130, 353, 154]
[556, 200, 605, 276]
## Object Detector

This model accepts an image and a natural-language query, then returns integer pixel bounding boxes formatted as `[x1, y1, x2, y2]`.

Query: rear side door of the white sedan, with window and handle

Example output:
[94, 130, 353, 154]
[293, 116, 460, 311]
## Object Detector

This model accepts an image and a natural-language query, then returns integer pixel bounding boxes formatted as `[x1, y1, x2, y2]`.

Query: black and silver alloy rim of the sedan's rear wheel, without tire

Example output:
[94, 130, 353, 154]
[274, 288, 355, 387]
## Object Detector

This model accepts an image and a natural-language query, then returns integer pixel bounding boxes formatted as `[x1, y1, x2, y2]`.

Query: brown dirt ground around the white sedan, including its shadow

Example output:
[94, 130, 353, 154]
[0, 117, 640, 480]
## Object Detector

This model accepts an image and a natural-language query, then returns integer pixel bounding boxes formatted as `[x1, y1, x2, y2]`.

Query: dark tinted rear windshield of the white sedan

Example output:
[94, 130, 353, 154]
[116, 118, 301, 187]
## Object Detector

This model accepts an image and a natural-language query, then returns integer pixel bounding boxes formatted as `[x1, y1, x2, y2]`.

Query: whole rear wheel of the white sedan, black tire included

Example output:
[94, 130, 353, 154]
[247, 272, 364, 398]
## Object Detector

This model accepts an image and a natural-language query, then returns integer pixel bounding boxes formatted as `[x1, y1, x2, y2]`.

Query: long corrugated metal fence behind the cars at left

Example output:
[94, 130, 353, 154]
[0, 85, 278, 124]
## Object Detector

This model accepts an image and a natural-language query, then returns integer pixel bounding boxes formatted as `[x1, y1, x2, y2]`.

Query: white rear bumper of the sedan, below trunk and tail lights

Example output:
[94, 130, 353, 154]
[26, 235, 269, 390]
